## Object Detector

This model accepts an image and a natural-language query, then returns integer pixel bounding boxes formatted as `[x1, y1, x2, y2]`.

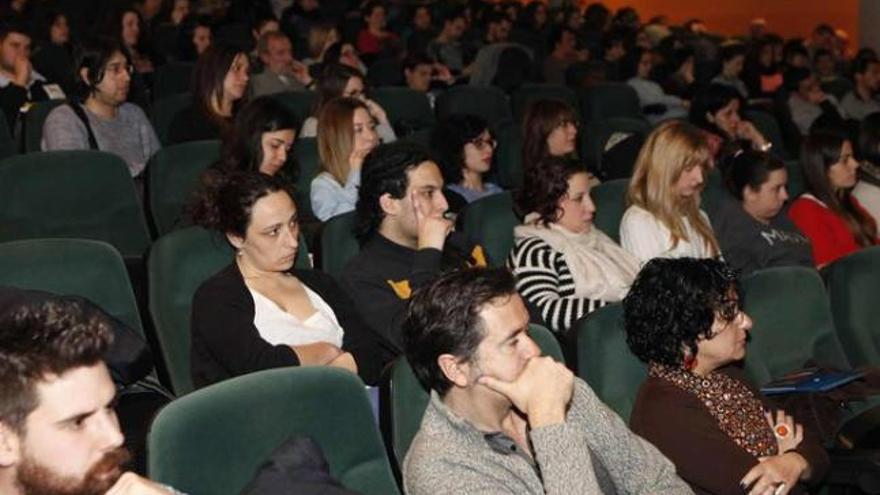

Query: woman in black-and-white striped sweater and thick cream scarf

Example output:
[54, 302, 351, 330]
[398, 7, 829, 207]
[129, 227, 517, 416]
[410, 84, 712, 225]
[507, 157, 639, 333]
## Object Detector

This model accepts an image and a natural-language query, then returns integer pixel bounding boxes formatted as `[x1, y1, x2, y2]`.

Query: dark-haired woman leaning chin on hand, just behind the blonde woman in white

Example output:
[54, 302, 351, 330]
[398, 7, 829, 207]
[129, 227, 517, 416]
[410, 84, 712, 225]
[689, 84, 773, 158]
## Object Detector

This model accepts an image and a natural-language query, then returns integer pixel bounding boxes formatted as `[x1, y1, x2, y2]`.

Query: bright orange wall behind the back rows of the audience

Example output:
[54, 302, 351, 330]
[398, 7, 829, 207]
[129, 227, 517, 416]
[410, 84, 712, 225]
[600, 0, 859, 44]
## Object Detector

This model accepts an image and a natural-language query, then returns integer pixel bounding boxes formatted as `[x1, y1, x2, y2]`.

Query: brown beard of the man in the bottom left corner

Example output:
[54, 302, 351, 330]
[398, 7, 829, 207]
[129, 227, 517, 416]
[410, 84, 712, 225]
[17, 447, 131, 495]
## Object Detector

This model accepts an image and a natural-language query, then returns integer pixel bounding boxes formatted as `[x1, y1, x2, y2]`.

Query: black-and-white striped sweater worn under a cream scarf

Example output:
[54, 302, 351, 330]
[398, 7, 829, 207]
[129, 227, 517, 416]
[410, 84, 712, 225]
[507, 237, 605, 332]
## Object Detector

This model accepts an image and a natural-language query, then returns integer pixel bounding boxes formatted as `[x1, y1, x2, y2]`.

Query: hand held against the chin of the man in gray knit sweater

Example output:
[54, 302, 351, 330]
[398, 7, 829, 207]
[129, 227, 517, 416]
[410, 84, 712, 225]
[478, 356, 574, 428]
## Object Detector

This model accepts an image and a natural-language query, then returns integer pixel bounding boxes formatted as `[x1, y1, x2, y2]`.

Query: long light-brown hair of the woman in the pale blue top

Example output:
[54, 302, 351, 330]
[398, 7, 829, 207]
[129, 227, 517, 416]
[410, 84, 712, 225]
[318, 98, 369, 185]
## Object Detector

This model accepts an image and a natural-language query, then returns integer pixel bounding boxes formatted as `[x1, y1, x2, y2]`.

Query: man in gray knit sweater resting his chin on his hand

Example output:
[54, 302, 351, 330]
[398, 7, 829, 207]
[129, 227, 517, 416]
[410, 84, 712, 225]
[403, 268, 691, 495]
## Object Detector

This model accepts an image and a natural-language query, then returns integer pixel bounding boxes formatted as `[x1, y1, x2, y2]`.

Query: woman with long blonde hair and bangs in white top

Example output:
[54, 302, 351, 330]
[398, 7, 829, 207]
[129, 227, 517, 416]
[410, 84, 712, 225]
[620, 121, 720, 263]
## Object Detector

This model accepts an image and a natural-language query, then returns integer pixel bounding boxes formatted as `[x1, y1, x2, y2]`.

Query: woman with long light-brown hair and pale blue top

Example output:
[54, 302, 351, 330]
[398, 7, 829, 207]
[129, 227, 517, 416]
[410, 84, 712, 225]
[309, 98, 379, 222]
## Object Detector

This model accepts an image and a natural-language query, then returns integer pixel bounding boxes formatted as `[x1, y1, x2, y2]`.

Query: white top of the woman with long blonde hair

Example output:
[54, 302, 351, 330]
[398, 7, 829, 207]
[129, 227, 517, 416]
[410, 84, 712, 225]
[620, 206, 713, 264]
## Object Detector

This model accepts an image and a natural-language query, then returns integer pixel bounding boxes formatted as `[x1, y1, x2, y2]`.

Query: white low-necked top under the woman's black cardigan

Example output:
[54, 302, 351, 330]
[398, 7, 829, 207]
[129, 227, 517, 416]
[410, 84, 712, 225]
[248, 284, 343, 347]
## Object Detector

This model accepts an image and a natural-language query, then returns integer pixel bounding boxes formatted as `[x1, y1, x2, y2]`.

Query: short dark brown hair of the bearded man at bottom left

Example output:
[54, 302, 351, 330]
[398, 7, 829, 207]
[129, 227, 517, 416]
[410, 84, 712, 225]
[0, 299, 113, 434]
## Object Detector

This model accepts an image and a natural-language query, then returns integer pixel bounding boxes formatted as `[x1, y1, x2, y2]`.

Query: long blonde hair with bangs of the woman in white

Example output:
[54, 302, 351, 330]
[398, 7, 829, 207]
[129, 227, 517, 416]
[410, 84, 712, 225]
[626, 121, 720, 255]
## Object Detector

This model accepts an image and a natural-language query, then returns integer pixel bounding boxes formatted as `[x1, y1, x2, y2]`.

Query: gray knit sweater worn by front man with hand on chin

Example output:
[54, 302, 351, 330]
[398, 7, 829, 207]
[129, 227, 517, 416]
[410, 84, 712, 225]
[403, 380, 692, 495]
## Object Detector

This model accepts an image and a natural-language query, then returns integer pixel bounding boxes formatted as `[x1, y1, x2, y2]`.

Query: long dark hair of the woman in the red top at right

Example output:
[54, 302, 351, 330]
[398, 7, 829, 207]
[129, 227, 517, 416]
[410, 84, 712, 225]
[801, 131, 877, 247]
